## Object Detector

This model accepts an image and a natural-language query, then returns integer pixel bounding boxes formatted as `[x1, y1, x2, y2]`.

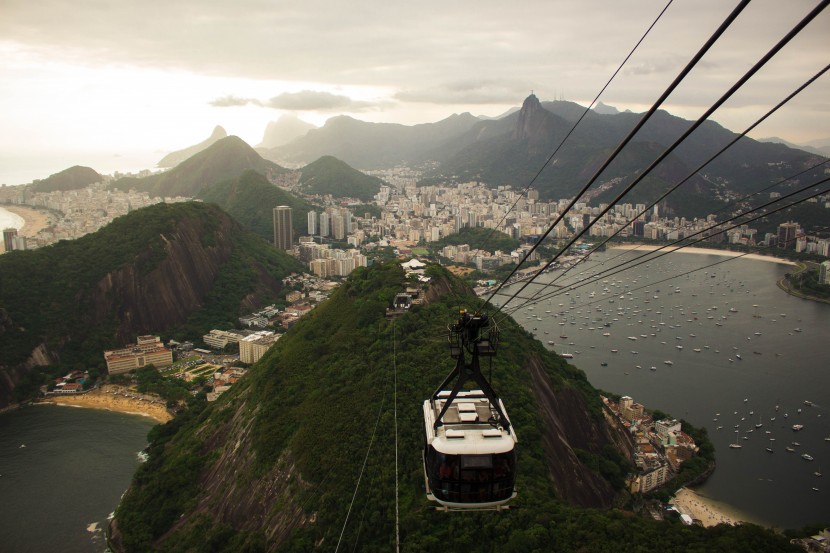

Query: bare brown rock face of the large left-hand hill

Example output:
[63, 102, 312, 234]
[0, 204, 290, 408]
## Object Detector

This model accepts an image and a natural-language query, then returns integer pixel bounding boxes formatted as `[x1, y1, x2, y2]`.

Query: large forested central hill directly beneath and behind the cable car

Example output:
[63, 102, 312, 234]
[112, 263, 789, 553]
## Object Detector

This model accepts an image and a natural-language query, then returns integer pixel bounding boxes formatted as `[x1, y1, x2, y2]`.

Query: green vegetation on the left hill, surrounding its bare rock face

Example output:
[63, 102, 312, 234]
[0, 203, 299, 382]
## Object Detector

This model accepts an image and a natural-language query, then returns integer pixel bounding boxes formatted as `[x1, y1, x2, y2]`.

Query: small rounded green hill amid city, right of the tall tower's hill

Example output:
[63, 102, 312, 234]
[300, 156, 383, 201]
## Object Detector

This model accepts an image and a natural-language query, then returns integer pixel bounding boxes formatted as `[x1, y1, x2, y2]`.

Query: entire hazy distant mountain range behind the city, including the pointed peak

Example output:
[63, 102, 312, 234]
[260, 95, 822, 216]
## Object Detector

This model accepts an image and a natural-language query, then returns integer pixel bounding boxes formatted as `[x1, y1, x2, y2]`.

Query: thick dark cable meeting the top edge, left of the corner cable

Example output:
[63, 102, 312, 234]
[484, 0, 752, 313]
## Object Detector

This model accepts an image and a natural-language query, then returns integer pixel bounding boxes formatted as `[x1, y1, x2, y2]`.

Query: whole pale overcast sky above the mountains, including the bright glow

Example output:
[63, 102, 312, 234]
[0, 0, 830, 184]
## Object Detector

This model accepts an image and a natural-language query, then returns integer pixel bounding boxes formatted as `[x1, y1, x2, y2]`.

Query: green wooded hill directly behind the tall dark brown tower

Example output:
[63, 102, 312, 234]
[198, 169, 314, 242]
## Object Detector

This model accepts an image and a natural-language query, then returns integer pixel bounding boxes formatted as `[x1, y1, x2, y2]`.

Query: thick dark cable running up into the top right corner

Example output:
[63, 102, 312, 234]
[496, 0, 830, 312]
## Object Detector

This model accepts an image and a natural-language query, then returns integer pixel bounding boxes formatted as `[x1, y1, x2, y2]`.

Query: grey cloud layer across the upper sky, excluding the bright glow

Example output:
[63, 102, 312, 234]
[0, 0, 830, 138]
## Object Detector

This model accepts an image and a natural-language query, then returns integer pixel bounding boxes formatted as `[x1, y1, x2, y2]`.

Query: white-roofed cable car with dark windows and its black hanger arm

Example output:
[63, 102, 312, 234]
[424, 311, 518, 511]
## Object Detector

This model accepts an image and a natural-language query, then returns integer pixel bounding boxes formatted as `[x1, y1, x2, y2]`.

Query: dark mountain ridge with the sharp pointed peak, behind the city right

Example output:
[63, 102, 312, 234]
[436, 95, 821, 216]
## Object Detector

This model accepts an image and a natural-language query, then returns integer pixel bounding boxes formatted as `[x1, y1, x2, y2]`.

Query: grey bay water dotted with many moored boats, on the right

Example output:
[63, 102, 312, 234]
[500, 250, 830, 527]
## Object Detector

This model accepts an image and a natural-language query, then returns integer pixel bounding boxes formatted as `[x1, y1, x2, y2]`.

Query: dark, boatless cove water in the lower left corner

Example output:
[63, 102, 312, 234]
[0, 405, 155, 553]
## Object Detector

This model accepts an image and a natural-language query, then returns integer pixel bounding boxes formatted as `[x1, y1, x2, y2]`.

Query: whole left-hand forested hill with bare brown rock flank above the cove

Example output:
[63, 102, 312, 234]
[0, 202, 299, 407]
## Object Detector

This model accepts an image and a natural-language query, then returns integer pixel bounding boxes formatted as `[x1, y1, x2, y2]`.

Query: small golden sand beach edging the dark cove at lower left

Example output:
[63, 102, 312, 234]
[42, 385, 173, 423]
